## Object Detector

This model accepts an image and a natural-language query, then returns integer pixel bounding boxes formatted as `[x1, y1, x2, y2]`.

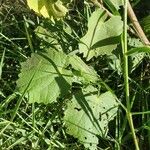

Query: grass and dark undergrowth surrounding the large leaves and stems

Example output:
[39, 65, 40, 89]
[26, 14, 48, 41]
[0, 0, 150, 150]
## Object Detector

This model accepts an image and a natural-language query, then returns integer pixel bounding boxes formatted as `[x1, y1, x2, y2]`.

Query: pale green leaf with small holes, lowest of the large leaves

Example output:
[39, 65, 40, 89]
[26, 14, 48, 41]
[64, 86, 118, 150]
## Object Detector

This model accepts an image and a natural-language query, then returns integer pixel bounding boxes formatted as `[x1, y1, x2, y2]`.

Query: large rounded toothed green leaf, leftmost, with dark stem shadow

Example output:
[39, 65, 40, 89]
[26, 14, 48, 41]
[17, 49, 72, 104]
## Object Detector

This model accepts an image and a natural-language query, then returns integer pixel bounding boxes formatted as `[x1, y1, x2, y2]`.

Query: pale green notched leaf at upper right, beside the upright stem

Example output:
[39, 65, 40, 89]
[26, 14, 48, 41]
[79, 9, 123, 60]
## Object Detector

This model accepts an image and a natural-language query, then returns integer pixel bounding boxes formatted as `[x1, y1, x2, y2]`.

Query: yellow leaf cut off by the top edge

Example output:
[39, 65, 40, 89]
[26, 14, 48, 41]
[27, 0, 68, 20]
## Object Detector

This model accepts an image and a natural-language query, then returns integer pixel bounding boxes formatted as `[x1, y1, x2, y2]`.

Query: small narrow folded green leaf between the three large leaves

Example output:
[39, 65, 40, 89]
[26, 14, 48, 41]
[69, 55, 98, 83]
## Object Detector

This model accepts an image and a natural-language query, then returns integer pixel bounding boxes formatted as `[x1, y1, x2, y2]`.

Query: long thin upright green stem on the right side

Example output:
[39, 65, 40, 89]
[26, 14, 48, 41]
[122, 0, 139, 150]
